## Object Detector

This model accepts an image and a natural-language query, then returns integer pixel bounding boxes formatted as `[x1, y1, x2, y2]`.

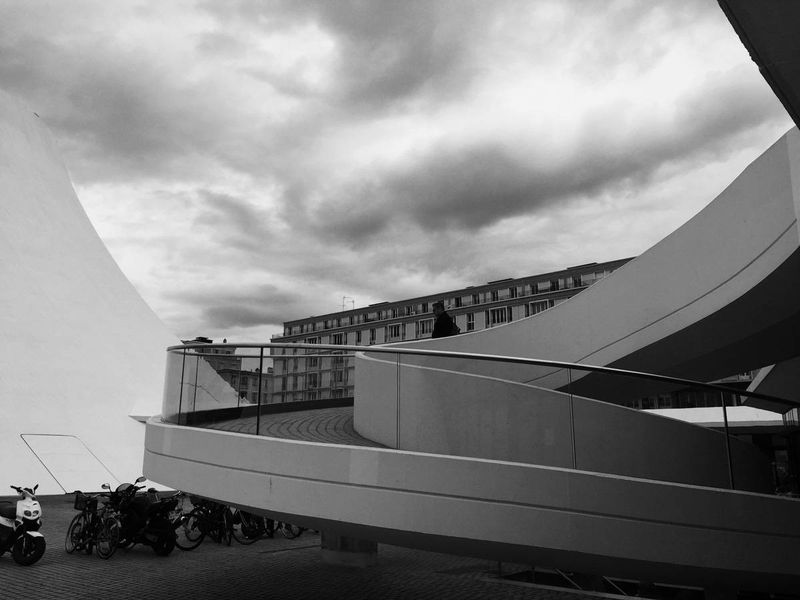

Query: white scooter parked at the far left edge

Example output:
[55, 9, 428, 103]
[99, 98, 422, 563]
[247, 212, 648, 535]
[0, 484, 46, 566]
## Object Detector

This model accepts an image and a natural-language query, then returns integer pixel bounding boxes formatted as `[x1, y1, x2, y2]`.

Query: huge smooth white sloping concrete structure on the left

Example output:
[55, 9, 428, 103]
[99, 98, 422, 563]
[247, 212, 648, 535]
[0, 92, 177, 494]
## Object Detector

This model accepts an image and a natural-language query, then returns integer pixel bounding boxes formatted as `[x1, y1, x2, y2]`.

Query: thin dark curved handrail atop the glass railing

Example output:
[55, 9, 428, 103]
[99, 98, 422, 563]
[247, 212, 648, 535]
[167, 342, 800, 411]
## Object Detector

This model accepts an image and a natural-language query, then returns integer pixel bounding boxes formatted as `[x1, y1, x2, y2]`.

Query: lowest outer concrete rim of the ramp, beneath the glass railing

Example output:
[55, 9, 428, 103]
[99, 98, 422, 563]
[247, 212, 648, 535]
[144, 419, 800, 590]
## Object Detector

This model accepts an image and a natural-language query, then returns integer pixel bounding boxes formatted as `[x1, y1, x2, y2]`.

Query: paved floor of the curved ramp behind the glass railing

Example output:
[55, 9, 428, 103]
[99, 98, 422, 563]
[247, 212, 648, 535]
[207, 406, 385, 448]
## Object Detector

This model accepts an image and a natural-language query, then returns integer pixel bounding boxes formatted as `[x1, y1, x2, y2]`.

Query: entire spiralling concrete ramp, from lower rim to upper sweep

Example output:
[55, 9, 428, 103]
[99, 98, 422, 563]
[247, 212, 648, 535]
[145, 3, 800, 593]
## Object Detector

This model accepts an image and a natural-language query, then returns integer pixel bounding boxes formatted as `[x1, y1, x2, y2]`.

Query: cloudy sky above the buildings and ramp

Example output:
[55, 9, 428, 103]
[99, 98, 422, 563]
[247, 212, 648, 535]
[0, 0, 791, 342]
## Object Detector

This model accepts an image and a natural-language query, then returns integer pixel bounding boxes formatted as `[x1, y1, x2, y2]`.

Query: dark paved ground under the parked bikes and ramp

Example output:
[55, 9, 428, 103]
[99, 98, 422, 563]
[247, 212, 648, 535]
[0, 495, 586, 600]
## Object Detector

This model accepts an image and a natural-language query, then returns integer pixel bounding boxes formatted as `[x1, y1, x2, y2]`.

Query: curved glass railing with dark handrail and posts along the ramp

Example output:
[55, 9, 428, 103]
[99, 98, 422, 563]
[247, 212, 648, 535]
[162, 343, 795, 492]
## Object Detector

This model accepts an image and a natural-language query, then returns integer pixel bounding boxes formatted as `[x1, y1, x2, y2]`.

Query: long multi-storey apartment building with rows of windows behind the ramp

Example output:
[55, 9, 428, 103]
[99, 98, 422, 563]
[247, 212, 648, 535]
[269, 258, 631, 402]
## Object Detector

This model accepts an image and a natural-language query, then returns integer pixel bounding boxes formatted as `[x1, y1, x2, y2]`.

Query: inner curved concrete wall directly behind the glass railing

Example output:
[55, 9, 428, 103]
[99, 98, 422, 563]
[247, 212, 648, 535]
[354, 358, 772, 492]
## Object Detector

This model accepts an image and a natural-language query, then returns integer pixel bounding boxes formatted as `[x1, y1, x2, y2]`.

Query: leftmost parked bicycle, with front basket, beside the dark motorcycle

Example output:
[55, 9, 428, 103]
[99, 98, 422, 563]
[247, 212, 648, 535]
[64, 490, 121, 559]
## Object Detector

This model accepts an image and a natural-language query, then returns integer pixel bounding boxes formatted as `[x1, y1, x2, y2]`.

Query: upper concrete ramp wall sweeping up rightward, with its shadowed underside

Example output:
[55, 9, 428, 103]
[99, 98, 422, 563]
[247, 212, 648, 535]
[365, 128, 800, 402]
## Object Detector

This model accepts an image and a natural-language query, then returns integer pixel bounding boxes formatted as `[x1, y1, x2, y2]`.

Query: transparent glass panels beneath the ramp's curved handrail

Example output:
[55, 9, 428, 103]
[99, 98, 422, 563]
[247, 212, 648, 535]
[163, 343, 798, 494]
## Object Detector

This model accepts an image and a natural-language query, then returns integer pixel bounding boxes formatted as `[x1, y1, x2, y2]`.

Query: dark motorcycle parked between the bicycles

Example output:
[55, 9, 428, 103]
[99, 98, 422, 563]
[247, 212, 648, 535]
[103, 477, 178, 556]
